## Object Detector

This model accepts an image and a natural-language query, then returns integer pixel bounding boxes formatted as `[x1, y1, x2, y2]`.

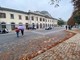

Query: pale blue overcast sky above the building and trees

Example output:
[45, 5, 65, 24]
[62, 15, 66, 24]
[0, 0, 73, 21]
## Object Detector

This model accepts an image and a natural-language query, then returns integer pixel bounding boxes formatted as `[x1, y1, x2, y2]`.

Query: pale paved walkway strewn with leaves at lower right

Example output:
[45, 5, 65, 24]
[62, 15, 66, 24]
[32, 31, 80, 60]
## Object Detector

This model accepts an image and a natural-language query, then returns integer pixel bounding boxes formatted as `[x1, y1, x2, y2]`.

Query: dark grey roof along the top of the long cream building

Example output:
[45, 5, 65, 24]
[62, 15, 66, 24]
[0, 7, 57, 20]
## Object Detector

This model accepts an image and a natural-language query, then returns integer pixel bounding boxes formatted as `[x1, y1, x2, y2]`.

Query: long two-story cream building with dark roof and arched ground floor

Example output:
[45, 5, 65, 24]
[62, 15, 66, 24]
[0, 7, 57, 31]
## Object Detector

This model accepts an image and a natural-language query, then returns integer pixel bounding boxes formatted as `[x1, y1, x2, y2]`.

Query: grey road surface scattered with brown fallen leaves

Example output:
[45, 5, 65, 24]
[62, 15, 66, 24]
[0, 28, 72, 60]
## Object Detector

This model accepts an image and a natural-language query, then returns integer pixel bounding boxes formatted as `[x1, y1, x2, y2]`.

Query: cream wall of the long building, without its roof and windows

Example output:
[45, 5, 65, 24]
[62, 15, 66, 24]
[0, 10, 57, 31]
